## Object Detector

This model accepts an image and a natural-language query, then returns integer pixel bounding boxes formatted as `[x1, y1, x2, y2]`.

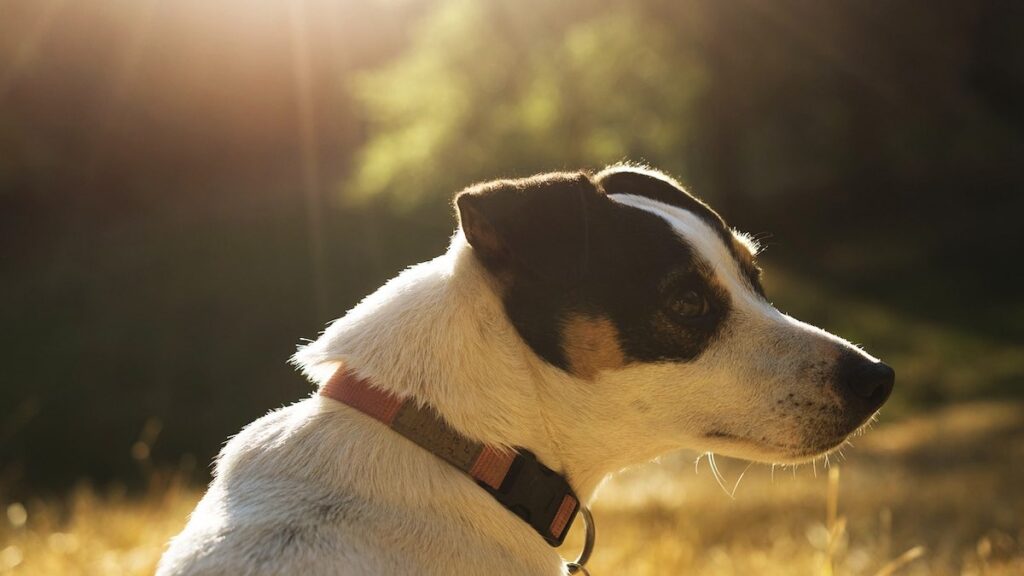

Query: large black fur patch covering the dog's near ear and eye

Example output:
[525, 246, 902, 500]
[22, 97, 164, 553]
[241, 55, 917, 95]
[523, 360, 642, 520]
[456, 167, 745, 370]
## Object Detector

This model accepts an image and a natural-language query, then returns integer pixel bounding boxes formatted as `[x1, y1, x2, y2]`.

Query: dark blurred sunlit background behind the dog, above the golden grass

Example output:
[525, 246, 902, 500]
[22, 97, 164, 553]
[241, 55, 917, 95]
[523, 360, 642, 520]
[0, 0, 1024, 565]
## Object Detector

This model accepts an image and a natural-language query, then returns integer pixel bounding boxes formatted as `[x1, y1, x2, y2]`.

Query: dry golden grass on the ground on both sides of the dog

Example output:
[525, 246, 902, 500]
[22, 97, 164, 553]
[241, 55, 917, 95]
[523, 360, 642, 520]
[0, 404, 1024, 576]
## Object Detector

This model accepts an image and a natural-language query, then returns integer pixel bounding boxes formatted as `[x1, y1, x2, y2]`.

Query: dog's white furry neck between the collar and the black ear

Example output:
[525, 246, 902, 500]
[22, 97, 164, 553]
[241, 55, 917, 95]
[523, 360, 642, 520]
[295, 233, 647, 502]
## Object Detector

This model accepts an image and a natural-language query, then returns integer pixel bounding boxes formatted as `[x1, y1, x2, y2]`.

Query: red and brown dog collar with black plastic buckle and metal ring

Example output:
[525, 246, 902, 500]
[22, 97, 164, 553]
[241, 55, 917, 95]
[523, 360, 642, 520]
[319, 367, 593, 545]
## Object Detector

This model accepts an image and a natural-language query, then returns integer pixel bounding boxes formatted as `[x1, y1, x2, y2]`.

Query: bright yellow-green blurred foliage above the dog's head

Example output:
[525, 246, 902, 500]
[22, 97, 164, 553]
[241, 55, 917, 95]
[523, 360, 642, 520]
[346, 0, 706, 208]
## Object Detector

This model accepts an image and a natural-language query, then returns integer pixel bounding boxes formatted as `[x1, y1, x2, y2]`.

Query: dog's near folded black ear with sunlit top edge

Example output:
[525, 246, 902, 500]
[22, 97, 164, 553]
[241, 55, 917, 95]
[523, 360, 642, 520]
[455, 172, 608, 281]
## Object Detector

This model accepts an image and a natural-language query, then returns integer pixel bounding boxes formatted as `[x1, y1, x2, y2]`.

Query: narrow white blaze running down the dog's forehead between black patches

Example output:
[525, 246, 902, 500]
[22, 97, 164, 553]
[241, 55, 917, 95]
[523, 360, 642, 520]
[608, 194, 764, 307]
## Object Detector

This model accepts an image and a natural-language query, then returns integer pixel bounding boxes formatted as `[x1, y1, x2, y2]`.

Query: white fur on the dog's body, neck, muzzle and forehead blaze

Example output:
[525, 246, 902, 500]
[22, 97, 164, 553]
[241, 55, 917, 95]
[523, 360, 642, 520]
[158, 172, 880, 576]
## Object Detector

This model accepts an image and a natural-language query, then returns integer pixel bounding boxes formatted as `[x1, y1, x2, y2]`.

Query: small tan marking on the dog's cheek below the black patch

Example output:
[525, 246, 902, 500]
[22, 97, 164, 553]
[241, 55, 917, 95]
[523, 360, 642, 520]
[562, 315, 626, 380]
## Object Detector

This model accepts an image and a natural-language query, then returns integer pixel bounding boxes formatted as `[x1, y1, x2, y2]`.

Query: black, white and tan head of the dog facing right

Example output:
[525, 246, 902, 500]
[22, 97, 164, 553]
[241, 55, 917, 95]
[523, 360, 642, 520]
[456, 166, 894, 462]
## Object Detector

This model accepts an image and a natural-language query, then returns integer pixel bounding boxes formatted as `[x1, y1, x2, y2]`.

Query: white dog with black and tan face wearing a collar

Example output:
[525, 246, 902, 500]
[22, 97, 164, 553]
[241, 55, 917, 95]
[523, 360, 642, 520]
[158, 165, 894, 576]
